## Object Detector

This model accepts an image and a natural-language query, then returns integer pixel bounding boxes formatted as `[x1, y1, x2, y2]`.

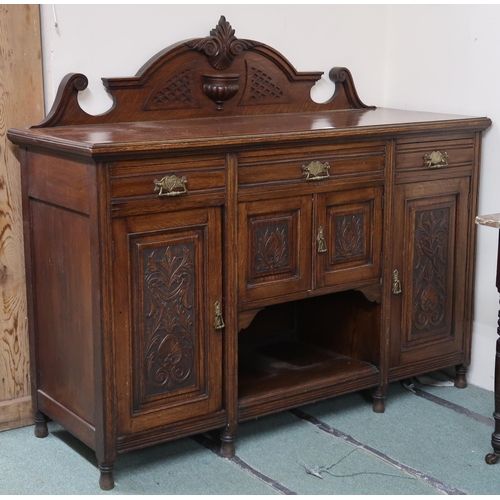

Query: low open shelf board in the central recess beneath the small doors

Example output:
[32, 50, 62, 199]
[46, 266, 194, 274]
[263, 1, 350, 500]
[238, 341, 380, 418]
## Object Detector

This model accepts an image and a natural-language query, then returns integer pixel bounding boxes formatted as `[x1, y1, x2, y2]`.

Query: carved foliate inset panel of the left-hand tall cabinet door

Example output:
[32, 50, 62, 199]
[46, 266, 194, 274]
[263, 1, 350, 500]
[143, 243, 195, 396]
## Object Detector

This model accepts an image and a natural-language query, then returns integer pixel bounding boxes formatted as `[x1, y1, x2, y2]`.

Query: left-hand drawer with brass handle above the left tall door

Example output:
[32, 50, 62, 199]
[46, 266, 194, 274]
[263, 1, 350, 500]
[111, 161, 226, 199]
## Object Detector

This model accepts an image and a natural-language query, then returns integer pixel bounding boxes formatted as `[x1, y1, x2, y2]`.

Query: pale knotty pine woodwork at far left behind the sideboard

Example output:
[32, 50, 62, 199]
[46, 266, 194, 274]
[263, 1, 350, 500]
[0, 5, 43, 430]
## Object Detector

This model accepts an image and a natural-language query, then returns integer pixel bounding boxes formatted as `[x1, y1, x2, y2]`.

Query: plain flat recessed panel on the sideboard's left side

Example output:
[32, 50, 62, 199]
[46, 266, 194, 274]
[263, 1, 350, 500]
[30, 200, 94, 423]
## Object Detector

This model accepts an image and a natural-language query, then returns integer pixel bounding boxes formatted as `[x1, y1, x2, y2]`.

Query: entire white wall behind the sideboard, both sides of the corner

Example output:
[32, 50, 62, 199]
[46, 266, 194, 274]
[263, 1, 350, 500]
[41, 4, 500, 389]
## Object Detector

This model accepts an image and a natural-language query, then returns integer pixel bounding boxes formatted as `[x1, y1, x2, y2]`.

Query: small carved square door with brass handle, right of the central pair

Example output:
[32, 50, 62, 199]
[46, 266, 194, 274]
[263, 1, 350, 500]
[314, 186, 383, 287]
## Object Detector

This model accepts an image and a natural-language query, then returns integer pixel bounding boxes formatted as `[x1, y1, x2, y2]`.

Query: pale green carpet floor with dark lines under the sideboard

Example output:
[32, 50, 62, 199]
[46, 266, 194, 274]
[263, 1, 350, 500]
[0, 383, 500, 495]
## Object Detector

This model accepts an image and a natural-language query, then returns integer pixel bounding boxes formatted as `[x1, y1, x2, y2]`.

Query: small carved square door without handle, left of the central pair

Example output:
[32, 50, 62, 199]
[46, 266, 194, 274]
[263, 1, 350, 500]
[238, 196, 312, 302]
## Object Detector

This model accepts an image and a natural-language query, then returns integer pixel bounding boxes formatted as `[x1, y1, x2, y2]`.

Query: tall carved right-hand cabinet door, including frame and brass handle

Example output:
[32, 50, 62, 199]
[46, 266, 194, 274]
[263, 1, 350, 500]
[390, 178, 469, 375]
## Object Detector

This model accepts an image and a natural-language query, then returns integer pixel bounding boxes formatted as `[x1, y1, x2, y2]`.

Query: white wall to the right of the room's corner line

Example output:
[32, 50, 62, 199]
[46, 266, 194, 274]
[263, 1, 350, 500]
[383, 5, 500, 390]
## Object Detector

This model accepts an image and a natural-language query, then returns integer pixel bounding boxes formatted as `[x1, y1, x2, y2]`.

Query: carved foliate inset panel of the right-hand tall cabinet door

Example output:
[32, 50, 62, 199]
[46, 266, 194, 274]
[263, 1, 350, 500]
[413, 208, 450, 333]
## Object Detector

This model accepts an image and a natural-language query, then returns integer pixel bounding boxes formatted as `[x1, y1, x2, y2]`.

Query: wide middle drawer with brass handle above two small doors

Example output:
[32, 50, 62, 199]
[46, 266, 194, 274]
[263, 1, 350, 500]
[238, 143, 385, 187]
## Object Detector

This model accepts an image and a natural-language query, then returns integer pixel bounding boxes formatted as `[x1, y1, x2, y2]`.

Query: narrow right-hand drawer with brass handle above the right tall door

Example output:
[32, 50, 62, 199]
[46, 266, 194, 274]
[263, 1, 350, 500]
[396, 138, 474, 171]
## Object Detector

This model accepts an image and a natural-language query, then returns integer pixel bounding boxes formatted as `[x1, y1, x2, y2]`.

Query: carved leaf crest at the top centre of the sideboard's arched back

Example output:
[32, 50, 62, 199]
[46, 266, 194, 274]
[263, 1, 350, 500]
[188, 16, 258, 70]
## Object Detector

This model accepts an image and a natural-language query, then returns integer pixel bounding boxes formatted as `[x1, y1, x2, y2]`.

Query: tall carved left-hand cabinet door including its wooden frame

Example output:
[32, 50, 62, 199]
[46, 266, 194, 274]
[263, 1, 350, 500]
[113, 207, 222, 434]
